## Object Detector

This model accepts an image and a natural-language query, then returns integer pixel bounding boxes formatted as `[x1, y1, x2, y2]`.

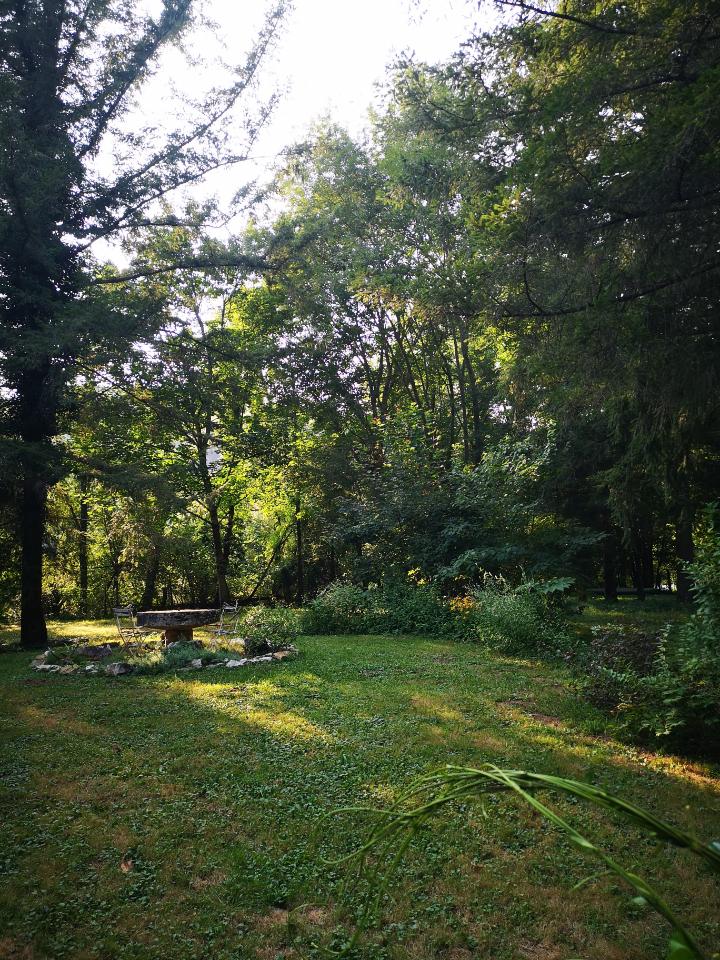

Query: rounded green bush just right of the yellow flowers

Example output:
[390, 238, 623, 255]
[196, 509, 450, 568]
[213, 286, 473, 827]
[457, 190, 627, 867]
[470, 575, 569, 654]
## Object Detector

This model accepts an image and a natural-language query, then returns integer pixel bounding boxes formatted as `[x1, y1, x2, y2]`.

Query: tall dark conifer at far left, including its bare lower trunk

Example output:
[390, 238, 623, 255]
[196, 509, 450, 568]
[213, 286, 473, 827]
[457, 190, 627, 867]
[0, 0, 283, 647]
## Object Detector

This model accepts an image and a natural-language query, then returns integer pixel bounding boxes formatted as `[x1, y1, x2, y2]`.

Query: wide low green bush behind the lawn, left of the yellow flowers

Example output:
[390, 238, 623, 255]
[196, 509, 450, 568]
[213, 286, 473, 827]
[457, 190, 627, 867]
[303, 582, 458, 635]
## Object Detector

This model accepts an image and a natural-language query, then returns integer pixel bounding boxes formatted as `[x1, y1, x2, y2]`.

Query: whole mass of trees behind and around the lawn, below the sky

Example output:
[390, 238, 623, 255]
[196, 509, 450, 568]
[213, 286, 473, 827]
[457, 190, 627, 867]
[0, 0, 720, 645]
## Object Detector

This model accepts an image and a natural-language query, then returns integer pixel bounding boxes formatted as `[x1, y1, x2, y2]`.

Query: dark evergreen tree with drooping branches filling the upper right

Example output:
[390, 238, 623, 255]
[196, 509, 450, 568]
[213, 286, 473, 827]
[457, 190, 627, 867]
[394, 0, 720, 598]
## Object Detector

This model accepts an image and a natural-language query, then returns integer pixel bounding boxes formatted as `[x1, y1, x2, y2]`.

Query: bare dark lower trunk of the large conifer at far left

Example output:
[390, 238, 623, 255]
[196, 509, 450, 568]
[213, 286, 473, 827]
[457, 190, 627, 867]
[20, 470, 47, 650]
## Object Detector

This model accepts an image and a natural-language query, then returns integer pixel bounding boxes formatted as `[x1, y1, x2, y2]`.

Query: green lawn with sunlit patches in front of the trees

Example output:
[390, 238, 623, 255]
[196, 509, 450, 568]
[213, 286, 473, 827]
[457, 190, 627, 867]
[0, 615, 720, 960]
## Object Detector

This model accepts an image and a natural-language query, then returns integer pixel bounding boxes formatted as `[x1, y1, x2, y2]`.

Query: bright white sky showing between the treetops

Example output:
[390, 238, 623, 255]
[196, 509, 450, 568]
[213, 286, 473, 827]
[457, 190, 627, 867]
[100, 0, 491, 263]
